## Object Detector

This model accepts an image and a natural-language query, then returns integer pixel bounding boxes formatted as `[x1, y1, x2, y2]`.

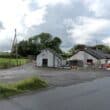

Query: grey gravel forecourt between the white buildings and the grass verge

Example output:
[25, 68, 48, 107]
[0, 63, 110, 87]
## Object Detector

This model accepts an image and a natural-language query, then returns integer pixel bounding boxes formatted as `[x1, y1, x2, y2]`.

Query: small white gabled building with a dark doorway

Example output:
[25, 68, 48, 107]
[36, 49, 63, 67]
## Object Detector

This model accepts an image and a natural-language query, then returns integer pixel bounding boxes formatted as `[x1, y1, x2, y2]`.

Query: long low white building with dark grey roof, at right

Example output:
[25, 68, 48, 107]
[68, 48, 110, 66]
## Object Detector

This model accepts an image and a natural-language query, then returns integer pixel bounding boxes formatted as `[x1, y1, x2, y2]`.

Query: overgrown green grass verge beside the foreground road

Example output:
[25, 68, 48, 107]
[0, 77, 47, 98]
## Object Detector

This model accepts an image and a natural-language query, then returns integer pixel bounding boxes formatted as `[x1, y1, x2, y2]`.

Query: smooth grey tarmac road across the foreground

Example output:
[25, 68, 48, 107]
[0, 77, 110, 110]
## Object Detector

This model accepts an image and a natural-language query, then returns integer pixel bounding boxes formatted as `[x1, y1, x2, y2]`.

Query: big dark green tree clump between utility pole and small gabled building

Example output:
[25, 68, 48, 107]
[13, 33, 62, 57]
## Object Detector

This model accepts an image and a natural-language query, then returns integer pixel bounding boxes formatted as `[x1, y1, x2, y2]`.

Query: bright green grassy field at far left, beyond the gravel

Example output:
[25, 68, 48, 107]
[0, 58, 28, 68]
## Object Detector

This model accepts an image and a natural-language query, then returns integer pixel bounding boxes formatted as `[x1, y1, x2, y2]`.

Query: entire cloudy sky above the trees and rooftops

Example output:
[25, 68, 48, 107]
[0, 0, 110, 51]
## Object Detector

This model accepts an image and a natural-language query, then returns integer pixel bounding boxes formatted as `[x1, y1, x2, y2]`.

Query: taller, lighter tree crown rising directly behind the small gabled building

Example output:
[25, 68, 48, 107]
[31, 33, 62, 53]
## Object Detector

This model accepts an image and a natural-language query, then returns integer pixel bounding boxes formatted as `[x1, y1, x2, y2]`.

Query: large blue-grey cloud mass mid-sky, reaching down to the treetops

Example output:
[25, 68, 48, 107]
[28, 1, 93, 49]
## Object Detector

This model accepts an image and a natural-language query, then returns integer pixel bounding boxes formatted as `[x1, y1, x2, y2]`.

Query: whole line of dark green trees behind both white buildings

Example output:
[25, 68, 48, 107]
[12, 33, 110, 59]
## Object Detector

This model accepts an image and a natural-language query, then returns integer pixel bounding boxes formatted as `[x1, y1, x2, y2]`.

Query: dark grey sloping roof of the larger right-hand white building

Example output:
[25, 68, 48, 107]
[84, 48, 110, 59]
